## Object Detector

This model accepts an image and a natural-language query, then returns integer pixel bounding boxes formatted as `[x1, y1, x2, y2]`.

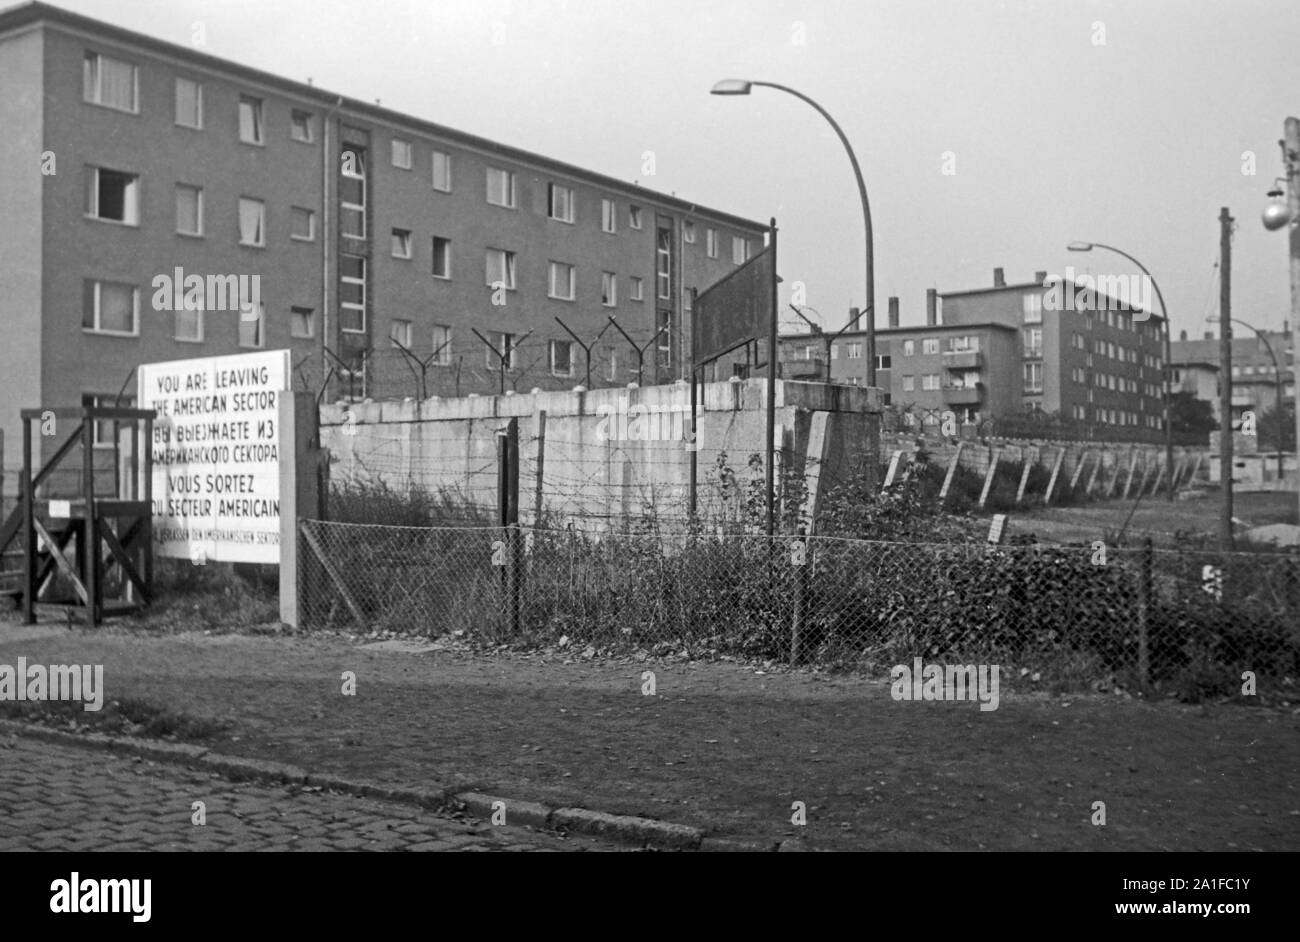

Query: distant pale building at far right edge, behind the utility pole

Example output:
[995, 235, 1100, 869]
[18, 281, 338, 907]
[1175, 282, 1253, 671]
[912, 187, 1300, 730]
[1170, 322, 1296, 422]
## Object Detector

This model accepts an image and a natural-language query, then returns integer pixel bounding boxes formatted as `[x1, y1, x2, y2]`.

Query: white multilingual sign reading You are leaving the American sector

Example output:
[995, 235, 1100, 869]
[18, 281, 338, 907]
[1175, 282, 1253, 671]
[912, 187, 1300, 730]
[138, 350, 293, 563]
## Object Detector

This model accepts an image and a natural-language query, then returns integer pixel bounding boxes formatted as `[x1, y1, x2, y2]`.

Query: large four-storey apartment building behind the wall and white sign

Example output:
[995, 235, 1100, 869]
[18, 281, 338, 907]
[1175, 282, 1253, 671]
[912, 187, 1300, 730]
[0, 3, 767, 490]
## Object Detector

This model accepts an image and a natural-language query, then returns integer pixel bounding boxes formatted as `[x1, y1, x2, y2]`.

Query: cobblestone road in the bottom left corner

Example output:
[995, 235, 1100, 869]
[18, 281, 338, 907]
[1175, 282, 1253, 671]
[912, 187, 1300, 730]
[0, 737, 620, 851]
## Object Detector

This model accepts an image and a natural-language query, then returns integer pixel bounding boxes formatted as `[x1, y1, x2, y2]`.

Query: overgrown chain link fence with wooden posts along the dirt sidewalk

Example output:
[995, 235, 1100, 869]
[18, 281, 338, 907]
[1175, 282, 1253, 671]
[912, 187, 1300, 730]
[300, 521, 1300, 699]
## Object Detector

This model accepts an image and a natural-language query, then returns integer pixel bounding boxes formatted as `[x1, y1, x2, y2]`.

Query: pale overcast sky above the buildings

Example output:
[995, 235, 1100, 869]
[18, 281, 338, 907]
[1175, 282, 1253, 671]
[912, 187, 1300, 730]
[55, 0, 1300, 337]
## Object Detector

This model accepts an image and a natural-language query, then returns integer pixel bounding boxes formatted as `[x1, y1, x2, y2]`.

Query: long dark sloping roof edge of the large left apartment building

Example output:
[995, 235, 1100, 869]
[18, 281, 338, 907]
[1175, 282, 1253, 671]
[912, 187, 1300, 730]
[0, 3, 767, 230]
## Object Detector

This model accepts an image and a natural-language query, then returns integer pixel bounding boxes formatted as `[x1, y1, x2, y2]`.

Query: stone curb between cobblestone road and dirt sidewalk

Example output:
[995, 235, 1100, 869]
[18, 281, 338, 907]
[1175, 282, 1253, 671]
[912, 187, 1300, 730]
[0, 720, 769, 852]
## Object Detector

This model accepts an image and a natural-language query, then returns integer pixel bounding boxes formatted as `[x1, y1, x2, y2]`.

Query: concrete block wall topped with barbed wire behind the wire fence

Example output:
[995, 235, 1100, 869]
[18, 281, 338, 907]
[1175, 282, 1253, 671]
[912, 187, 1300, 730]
[321, 379, 880, 529]
